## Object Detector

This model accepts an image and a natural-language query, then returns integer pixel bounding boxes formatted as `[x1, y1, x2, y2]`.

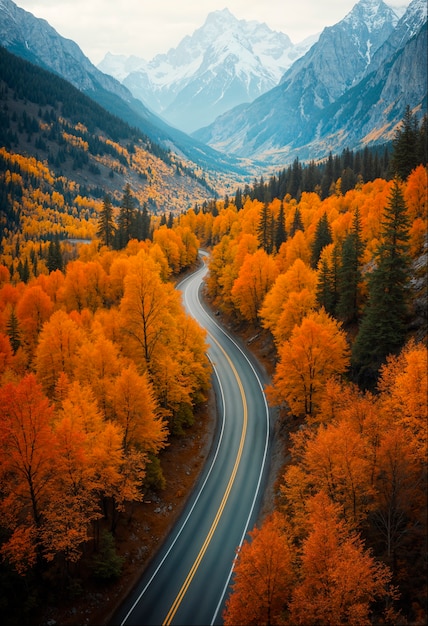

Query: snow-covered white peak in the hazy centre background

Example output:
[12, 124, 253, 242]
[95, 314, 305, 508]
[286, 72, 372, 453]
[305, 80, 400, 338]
[98, 9, 317, 132]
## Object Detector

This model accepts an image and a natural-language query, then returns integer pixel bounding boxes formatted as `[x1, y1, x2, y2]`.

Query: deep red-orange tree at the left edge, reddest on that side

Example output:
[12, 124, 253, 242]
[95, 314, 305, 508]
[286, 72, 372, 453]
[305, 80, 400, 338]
[0, 374, 58, 574]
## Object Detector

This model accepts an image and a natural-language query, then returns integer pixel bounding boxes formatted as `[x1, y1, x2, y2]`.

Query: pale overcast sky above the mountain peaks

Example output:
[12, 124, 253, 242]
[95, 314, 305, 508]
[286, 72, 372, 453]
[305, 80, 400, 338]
[15, 0, 410, 64]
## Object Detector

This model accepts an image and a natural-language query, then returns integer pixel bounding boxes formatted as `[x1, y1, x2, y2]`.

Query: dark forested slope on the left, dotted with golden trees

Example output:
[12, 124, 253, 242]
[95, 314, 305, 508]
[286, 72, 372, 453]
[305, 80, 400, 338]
[0, 46, 215, 214]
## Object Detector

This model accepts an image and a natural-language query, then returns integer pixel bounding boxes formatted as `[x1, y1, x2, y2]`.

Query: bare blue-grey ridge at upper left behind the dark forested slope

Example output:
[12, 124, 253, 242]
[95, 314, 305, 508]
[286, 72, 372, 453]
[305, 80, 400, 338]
[0, 0, 247, 173]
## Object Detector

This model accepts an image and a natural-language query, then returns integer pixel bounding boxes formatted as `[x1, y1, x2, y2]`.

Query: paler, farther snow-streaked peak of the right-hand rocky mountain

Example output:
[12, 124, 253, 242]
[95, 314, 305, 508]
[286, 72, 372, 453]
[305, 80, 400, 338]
[194, 0, 404, 159]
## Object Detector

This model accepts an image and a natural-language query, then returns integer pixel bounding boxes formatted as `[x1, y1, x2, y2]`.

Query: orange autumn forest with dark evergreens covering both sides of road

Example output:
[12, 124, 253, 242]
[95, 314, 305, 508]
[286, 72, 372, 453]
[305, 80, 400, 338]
[0, 45, 427, 626]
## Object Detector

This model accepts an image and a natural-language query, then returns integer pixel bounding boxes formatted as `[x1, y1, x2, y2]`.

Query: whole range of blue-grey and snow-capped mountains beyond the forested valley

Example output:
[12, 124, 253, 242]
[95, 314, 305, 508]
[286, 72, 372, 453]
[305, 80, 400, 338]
[0, 0, 427, 171]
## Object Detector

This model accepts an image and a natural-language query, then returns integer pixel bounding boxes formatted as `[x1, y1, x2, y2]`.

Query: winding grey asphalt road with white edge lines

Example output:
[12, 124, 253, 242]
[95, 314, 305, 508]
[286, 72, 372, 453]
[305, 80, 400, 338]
[112, 254, 269, 626]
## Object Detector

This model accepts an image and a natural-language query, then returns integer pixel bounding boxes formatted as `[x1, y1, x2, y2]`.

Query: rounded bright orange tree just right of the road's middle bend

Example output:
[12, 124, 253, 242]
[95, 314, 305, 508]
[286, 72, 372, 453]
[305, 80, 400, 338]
[268, 309, 349, 415]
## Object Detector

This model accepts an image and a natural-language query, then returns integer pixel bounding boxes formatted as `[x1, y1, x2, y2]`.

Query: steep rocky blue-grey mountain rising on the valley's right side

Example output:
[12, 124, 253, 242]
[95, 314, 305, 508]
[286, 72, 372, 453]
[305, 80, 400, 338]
[194, 0, 426, 163]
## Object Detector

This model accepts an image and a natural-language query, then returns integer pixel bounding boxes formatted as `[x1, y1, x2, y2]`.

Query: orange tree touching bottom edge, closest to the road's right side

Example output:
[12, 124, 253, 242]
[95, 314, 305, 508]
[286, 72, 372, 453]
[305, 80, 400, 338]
[223, 513, 294, 626]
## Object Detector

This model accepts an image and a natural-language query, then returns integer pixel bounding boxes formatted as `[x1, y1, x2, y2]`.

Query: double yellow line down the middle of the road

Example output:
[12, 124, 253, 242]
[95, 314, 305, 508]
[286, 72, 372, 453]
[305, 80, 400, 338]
[162, 336, 248, 626]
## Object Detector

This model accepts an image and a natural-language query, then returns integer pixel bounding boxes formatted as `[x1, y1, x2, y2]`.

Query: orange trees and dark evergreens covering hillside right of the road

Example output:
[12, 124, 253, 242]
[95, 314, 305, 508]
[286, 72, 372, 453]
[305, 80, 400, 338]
[192, 116, 428, 626]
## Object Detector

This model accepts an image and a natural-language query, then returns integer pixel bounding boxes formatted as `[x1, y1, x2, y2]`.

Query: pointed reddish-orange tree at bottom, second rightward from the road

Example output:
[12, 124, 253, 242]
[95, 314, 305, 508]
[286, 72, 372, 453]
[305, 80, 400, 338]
[289, 492, 394, 626]
